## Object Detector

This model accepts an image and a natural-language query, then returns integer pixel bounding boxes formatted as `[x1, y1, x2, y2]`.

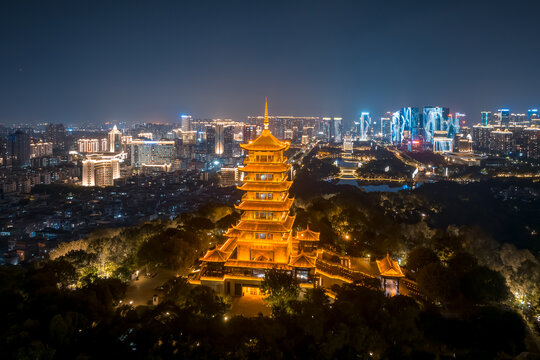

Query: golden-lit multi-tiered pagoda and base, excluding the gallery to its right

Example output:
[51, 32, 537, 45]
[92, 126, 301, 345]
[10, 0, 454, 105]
[199, 103, 319, 296]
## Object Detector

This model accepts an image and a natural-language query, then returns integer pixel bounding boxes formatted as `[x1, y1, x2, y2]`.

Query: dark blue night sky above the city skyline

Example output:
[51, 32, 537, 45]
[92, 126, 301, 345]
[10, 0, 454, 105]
[0, 0, 540, 123]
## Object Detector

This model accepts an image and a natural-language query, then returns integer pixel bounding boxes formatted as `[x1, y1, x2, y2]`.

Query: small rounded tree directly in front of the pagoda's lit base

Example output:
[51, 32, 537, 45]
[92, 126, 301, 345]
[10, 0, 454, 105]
[261, 269, 300, 312]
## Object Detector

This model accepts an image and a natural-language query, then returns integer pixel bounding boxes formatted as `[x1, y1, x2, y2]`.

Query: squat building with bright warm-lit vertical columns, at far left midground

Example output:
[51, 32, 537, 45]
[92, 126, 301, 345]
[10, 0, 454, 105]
[82, 154, 120, 186]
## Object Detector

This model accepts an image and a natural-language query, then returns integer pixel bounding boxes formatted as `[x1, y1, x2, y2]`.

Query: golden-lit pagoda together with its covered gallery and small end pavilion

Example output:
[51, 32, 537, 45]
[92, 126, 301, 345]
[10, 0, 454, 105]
[194, 104, 404, 296]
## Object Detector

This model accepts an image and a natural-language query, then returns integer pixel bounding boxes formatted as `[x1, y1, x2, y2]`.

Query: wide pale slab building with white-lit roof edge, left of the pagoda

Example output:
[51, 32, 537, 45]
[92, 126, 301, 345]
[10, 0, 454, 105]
[131, 139, 176, 168]
